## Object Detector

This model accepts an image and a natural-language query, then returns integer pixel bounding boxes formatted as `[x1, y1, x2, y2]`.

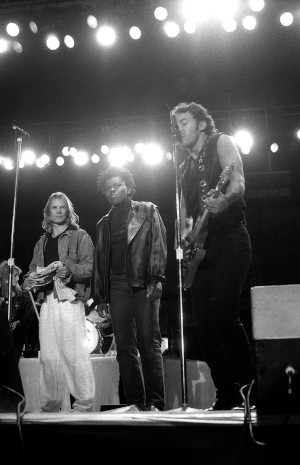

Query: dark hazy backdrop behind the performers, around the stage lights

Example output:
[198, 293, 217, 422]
[0, 0, 300, 348]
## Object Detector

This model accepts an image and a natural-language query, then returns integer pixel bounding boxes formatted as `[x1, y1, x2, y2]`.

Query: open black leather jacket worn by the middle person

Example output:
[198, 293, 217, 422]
[92, 200, 167, 304]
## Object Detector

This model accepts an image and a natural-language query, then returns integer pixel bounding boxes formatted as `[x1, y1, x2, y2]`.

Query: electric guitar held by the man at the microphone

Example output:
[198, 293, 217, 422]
[182, 162, 234, 289]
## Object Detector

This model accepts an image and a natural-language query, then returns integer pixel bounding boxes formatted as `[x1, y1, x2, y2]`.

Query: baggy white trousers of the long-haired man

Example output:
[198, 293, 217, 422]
[39, 292, 95, 412]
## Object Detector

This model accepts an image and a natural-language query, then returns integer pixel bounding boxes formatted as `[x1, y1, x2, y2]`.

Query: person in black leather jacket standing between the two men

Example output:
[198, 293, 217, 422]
[93, 167, 167, 410]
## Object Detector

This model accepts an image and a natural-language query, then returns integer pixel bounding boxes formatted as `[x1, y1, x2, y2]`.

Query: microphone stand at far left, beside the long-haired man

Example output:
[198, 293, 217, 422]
[7, 124, 29, 326]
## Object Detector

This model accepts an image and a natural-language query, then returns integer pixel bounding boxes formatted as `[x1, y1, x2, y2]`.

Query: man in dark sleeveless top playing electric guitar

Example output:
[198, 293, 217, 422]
[172, 102, 253, 410]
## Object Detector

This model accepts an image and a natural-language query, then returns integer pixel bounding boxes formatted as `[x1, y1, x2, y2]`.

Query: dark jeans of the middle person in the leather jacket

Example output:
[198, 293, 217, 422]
[110, 274, 165, 410]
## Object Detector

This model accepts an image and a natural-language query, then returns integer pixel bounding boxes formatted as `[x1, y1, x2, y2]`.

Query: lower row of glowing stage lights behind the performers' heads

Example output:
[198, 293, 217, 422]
[0, 129, 300, 171]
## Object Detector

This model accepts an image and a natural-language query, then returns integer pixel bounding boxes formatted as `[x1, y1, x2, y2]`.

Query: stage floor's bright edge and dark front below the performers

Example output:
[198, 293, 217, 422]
[0, 400, 300, 465]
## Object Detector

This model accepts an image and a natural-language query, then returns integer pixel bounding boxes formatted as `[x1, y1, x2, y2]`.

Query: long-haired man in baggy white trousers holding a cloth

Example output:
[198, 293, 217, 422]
[27, 192, 95, 412]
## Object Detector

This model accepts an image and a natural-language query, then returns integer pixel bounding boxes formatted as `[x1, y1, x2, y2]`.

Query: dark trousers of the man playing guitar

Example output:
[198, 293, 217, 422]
[191, 223, 253, 390]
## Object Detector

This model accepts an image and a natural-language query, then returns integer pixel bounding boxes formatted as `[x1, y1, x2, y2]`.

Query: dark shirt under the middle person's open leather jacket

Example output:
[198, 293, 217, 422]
[110, 199, 131, 274]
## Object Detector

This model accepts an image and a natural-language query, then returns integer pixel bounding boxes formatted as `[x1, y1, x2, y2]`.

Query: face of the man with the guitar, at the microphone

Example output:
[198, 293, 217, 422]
[175, 111, 206, 149]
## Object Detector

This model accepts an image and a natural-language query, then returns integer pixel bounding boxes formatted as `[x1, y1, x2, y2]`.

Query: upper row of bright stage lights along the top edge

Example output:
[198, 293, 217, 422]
[0, 0, 300, 53]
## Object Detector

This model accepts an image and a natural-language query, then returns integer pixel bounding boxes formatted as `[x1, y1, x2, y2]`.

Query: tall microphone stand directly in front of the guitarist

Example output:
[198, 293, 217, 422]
[170, 112, 188, 410]
